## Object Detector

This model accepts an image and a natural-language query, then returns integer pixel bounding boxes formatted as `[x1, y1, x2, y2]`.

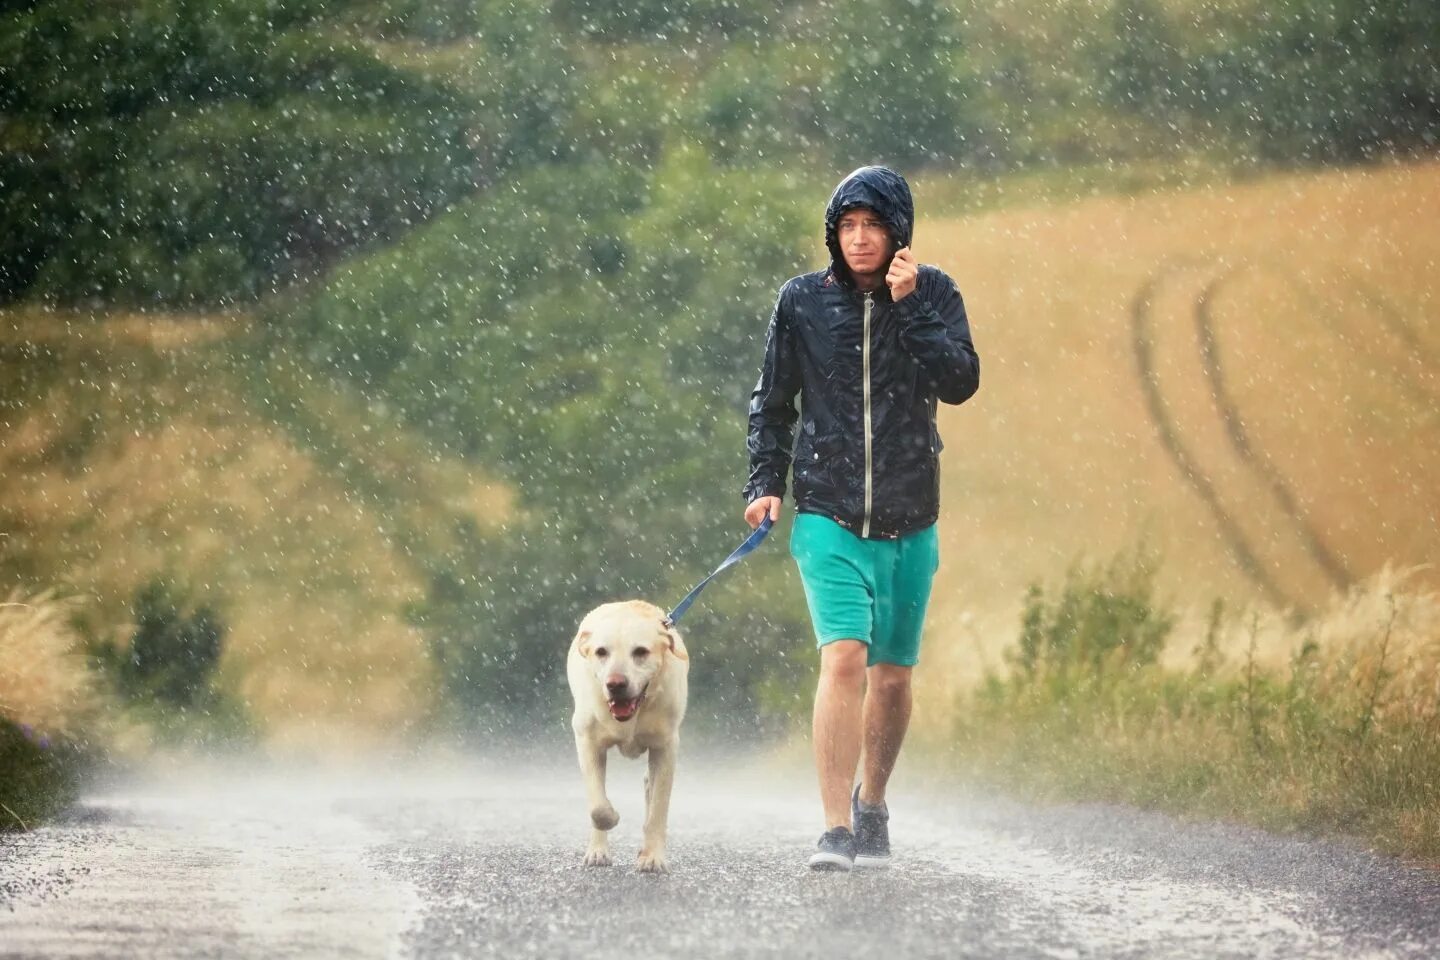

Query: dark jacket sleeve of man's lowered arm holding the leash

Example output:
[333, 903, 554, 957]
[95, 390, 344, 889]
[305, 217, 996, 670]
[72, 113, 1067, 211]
[742, 288, 801, 502]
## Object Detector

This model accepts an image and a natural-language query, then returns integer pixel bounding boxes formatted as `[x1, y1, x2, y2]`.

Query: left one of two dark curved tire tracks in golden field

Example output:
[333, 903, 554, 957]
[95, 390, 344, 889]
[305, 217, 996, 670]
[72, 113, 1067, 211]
[1130, 262, 1293, 607]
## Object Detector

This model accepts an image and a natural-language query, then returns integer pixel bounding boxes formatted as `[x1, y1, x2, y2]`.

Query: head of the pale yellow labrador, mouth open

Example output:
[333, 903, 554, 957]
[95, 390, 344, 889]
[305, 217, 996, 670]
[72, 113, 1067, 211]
[575, 600, 690, 721]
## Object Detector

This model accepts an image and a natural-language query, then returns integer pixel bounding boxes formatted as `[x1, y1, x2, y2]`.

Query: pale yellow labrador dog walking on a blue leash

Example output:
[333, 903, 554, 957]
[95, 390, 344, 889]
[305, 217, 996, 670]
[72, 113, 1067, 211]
[566, 600, 690, 874]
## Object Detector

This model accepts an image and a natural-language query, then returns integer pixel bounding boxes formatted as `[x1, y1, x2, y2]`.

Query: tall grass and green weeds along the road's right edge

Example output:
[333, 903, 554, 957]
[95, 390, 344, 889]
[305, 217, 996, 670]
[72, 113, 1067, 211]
[950, 554, 1440, 862]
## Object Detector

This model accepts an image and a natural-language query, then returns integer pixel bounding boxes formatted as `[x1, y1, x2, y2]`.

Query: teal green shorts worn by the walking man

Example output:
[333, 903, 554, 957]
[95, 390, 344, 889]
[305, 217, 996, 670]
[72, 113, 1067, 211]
[791, 514, 940, 666]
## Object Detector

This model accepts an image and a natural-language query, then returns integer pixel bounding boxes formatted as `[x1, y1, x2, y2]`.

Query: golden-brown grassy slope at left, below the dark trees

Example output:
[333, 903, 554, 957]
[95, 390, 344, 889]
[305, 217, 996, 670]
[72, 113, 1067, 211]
[0, 311, 505, 748]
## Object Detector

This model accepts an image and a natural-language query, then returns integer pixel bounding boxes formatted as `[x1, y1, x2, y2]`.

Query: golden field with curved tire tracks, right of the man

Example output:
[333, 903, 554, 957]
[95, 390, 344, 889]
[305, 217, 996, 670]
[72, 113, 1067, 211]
[916, 161, 1440, 672]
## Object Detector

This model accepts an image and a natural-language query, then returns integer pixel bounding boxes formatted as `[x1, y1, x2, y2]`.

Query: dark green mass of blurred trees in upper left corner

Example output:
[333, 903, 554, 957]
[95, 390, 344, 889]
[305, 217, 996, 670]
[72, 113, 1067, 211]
[0, 0, 564, 304]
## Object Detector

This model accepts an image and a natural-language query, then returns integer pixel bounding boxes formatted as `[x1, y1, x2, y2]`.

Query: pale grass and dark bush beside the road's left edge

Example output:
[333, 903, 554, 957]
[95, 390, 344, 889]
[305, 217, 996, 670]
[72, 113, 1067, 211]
[0, 579, 262, 830]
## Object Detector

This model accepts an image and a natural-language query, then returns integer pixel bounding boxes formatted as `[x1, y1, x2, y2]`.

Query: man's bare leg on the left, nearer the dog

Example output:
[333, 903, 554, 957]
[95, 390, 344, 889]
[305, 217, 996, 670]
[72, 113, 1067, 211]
[814, 640, 867, 830]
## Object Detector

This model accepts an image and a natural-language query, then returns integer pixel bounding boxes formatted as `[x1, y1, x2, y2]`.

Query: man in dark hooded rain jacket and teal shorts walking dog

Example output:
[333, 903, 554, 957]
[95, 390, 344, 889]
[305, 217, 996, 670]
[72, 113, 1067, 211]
[744, 167, 981, 871]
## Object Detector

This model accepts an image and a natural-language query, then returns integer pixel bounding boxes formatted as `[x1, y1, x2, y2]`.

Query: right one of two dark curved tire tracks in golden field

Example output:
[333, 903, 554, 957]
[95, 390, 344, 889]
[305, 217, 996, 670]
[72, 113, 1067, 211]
[1195, 266, 1355, 590]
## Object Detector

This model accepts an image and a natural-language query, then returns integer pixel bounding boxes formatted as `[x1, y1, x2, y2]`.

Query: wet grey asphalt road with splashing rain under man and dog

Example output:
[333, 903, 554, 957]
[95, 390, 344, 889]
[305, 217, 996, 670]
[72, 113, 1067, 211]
[0, 753, 1440, 960]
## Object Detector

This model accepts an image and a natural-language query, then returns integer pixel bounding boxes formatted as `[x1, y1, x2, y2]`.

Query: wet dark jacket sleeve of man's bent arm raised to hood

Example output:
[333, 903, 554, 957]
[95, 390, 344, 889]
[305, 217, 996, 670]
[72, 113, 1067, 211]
[896, 268, 981, 403]
